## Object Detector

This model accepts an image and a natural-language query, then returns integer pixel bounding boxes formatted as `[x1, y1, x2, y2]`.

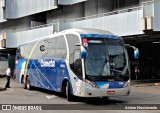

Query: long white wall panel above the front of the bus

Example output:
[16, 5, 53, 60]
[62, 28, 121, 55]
[60, 9, 143, 36]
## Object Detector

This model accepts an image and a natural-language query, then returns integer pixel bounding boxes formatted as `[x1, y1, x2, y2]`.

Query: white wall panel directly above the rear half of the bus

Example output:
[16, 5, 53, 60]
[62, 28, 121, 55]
[6, 26, 53, 48]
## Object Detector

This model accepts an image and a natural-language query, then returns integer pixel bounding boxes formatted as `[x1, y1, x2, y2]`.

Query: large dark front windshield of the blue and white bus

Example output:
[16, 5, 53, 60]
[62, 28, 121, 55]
[85, 39, 129, 77]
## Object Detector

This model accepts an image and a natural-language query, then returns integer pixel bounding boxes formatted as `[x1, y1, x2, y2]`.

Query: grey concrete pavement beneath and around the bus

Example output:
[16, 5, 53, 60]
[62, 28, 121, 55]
[0, 77, 160, 113]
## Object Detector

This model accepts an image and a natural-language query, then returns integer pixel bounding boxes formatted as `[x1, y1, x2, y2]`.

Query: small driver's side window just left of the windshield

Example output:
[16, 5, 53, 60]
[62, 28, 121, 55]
[73, 50, 82, 77]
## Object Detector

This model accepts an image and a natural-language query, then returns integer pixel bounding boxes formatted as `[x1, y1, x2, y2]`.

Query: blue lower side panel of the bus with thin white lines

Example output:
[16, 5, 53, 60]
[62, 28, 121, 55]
[16, 58, 73, 94]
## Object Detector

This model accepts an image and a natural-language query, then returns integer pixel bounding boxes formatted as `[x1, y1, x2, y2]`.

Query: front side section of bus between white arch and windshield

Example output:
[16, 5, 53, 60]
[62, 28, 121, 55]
[66, 34, 85, 94]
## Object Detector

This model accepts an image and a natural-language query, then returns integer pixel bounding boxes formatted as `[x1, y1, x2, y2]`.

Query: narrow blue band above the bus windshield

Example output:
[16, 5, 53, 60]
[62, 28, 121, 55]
[80, 34, 122, 39]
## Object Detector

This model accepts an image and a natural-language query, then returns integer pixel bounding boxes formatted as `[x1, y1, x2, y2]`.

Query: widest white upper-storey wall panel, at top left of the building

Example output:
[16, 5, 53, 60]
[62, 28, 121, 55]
[6, 0, 57, 19]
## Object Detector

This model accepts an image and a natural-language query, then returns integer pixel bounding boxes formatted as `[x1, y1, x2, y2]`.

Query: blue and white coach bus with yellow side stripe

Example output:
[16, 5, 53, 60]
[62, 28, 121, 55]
[16, 29, 138, 100]
